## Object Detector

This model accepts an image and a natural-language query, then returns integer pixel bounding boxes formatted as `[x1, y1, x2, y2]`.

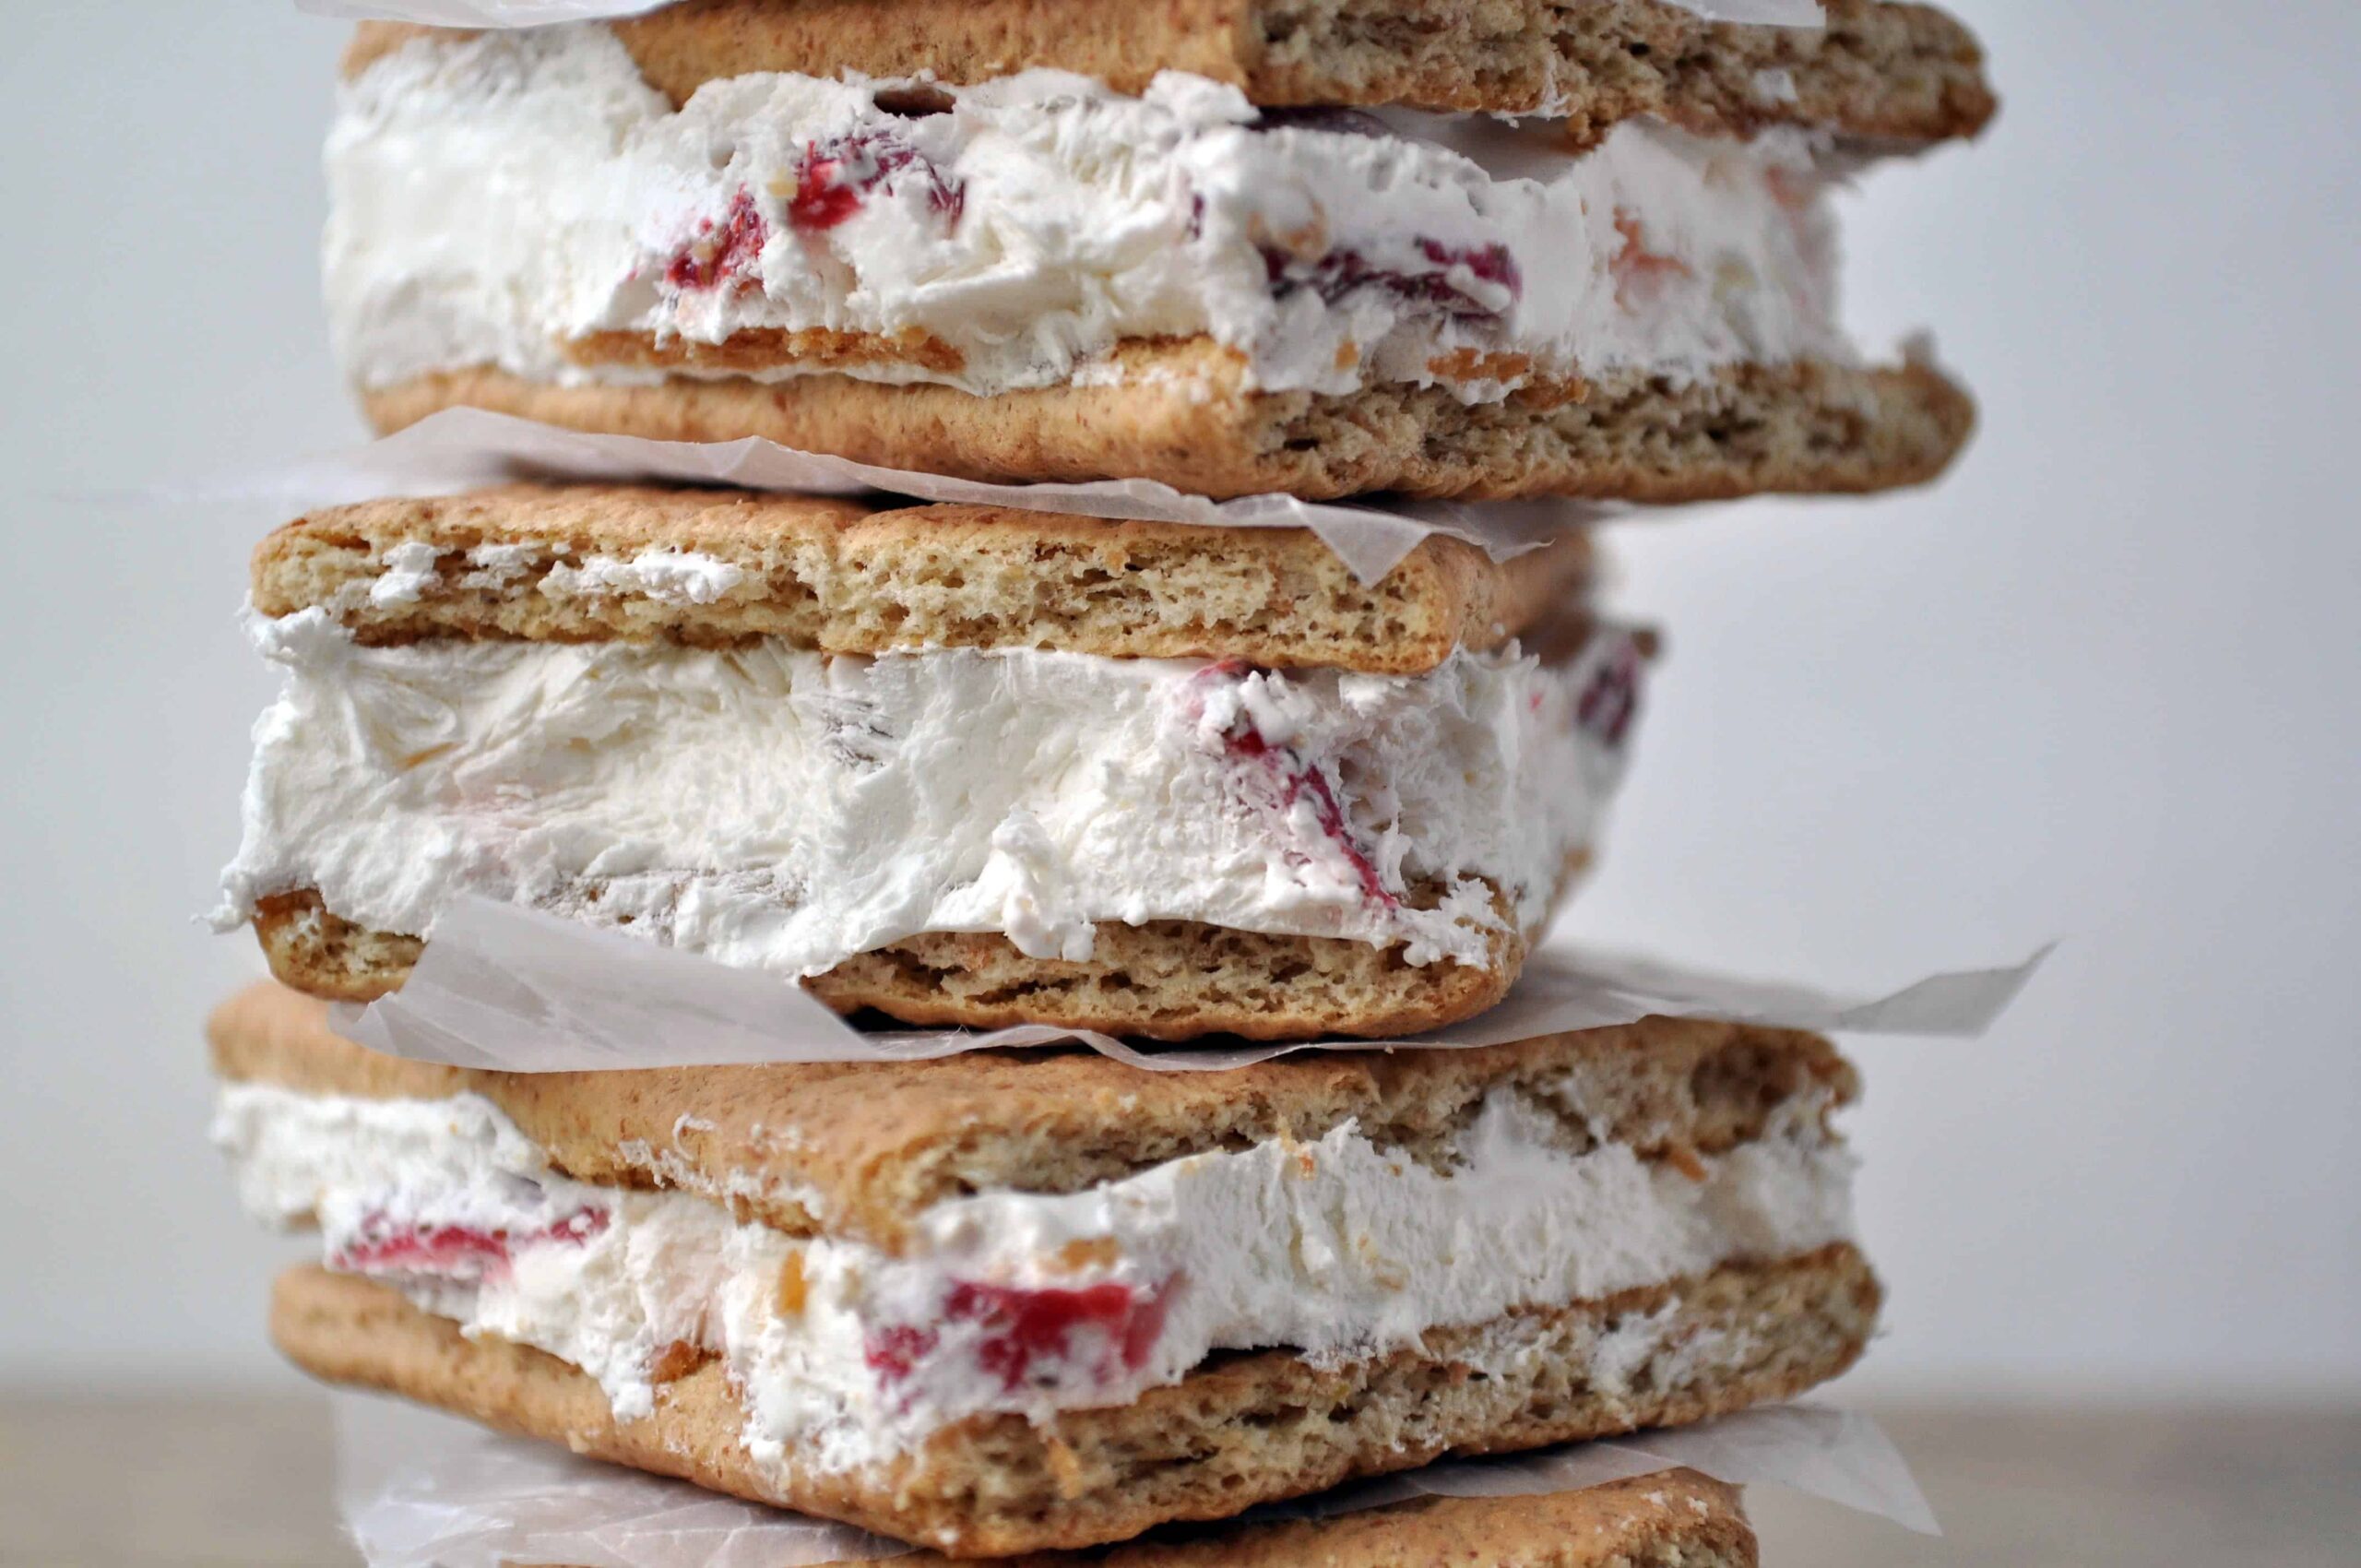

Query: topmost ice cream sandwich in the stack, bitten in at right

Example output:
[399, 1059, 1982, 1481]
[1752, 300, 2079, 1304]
[326, 0, 1976, 503]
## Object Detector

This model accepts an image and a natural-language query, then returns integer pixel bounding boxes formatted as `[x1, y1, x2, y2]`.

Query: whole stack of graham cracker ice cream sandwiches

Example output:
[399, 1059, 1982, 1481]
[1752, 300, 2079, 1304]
[210, 0, 1993, 1568]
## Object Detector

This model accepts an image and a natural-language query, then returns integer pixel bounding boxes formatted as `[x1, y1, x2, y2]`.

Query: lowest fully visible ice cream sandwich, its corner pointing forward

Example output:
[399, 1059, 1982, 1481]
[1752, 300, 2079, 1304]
[225, 985, 1880, 1556]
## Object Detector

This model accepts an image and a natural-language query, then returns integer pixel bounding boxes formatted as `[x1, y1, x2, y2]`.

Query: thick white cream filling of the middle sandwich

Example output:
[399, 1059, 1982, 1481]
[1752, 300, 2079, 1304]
[215, 609, 1641, 978]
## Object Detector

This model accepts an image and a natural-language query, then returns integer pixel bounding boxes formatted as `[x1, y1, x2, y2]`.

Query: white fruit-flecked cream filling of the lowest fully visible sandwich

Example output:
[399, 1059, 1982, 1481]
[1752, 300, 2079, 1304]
[215, 1084, 1854, 1468]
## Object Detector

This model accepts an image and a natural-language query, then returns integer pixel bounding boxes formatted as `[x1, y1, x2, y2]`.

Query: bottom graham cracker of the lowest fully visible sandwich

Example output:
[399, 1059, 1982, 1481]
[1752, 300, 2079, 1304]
[271, 1244, 1880, 1556]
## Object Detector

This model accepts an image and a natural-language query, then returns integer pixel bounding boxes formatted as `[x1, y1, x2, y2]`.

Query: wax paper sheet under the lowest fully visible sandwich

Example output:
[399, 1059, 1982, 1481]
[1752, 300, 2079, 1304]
[338, 1396, 1936, 1568]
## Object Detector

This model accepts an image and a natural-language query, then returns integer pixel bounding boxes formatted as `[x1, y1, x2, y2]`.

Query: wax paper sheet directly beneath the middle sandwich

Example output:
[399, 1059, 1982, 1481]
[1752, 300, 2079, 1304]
[330, 895, 2047, 1072]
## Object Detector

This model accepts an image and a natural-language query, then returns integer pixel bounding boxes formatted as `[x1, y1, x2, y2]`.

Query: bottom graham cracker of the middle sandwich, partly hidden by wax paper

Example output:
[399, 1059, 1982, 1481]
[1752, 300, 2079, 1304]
[255, 890, 1525, 1039]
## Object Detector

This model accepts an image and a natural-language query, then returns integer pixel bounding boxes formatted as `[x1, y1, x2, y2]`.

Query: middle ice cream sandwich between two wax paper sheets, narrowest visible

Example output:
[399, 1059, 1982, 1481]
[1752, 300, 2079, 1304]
[218, 486, 1650, 1039]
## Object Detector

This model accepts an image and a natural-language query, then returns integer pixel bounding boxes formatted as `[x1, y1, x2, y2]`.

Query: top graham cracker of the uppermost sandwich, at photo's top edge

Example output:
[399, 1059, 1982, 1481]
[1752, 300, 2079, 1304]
[345, 0, 1995, 144]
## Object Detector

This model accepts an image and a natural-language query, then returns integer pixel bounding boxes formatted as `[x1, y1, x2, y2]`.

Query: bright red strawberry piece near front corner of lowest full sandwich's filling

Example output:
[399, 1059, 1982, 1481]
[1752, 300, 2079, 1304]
[861, 1280, 1176, 1394]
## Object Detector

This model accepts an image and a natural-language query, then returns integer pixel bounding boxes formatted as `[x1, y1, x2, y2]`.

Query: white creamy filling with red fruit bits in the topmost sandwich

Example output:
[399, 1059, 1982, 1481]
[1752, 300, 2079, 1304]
[326, 26, 1851, 399]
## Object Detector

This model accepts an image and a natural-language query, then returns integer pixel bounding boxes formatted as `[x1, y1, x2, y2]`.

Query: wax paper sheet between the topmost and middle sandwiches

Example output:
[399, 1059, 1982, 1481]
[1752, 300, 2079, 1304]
[208, 409, 1629, 583]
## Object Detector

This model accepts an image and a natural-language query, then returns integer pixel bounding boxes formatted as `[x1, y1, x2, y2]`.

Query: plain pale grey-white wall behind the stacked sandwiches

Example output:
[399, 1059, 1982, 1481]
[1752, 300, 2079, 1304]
[0, 0, 2361, 1400]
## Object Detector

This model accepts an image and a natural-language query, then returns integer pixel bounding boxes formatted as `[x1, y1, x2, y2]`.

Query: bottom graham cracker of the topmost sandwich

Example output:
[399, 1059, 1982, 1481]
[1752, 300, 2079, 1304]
[362, 340, 1976, 503]
